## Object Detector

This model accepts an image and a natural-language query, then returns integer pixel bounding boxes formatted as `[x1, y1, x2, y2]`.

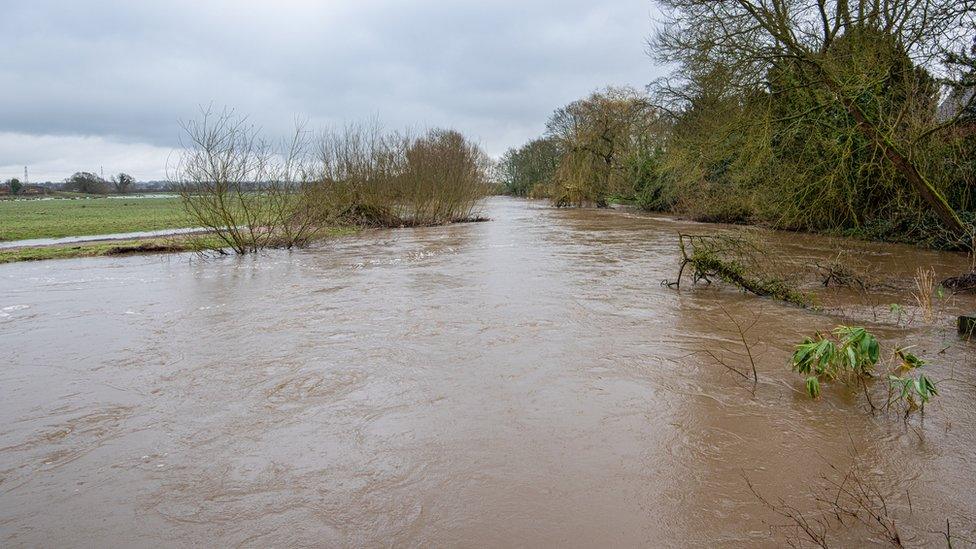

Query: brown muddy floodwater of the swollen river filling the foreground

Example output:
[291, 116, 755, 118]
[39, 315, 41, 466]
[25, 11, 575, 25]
[0, 198, 976, 547]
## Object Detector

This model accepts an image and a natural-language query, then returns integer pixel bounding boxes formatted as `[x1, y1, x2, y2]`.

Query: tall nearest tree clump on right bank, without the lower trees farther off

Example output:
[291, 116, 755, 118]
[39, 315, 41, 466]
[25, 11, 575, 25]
[652, 0, 976, 246]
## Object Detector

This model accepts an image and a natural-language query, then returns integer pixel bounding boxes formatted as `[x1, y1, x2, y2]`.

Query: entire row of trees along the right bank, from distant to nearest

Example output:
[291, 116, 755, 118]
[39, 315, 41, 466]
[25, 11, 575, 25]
[500, 0, 976, 246]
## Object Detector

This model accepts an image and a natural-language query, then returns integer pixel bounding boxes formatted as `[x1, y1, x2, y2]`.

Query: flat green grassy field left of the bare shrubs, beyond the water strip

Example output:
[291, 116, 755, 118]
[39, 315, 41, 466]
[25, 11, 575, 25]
[0, 197, 193, 241]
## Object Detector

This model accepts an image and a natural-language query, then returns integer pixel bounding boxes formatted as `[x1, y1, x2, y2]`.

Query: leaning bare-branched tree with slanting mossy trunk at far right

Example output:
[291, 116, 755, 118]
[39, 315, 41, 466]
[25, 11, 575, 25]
[652, 0, 976, 242]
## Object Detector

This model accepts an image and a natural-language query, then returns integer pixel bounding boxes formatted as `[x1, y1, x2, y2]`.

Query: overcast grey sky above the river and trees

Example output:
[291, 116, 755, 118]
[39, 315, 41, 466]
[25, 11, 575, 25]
[0, 0, 659, 181]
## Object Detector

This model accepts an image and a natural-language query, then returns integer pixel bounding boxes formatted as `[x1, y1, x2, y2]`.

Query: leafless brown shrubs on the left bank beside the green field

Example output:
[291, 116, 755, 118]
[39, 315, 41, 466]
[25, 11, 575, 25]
[171, 111, 489, 254]
